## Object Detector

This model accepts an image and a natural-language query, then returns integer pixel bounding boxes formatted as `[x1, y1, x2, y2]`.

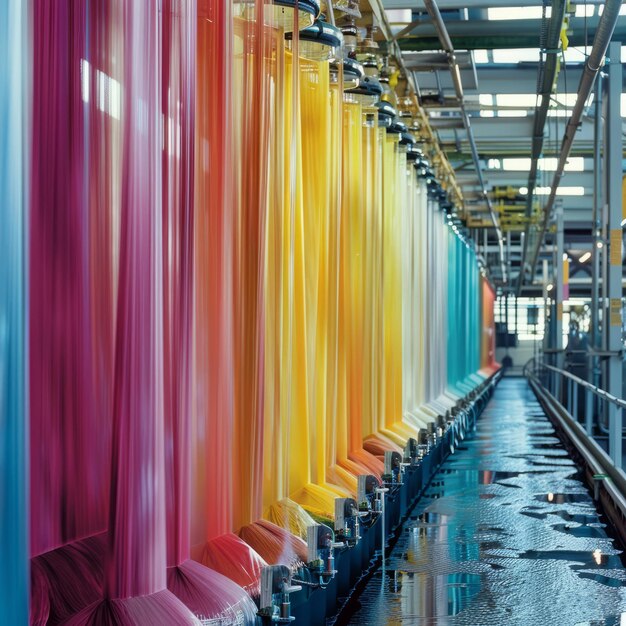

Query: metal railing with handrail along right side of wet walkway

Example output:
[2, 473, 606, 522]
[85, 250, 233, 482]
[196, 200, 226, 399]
[524, 357, 626, 458]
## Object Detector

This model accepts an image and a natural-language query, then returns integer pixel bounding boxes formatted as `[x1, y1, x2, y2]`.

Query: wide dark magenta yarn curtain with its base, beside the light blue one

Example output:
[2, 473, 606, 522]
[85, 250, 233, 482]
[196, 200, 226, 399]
[29, 0, 114, 624]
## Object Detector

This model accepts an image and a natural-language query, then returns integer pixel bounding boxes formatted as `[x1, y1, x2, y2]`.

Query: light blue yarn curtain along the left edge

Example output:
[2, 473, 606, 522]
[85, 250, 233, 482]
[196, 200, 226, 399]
[0, 0, 29, 626]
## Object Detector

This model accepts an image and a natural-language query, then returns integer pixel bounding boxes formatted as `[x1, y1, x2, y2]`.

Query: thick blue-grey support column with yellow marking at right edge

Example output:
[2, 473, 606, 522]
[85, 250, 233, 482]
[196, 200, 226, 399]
[603, 42, 622, 467]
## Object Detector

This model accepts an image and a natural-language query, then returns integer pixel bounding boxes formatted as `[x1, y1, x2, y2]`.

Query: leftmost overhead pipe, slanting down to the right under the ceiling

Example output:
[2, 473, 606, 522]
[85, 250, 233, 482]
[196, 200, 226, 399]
[424, 0, 507, 283]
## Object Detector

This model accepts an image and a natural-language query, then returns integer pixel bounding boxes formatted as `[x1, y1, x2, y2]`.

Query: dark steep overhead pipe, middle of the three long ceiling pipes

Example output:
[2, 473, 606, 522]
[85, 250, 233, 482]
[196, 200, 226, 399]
[517, 0, 566, 296]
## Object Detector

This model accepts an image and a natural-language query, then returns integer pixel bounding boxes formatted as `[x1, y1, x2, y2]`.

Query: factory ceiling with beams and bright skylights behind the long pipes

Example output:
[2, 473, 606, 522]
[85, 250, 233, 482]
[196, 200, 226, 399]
[361, 0, 626, 292]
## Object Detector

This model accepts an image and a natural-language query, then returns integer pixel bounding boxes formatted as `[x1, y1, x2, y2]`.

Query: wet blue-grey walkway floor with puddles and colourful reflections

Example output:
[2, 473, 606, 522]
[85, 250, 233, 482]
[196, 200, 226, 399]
[350, 378, 626, 626]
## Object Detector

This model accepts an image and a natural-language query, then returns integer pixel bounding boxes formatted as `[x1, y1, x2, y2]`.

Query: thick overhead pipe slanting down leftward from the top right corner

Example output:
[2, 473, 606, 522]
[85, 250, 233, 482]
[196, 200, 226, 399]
[530, 0, 622, 277]
